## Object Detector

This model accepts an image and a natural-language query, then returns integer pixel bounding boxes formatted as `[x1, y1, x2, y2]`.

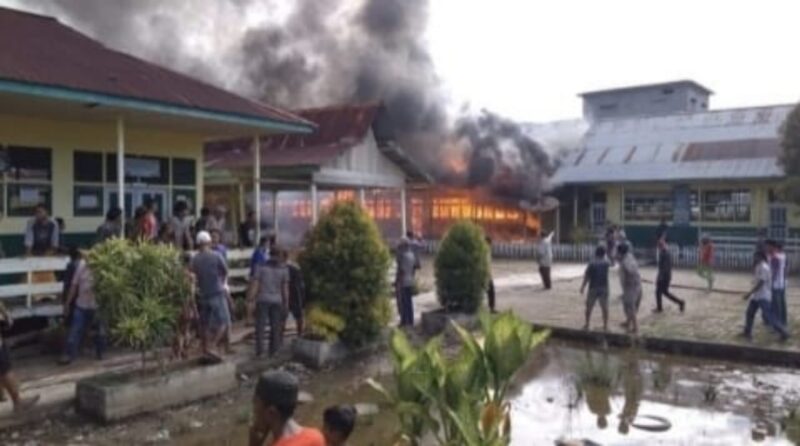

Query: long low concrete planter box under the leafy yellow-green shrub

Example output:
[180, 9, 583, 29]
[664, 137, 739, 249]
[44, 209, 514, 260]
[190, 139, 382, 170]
[75, 360, 238, 422]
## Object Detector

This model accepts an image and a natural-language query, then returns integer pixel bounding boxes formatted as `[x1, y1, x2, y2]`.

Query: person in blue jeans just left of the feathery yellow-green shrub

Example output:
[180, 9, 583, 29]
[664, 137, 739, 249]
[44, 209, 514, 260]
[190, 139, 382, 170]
[59, 260, 106, 365]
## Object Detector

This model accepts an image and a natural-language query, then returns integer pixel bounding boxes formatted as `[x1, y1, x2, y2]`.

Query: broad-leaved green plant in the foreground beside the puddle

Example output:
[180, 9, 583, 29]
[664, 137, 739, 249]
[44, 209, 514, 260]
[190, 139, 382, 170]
[369, 312, 549, 446]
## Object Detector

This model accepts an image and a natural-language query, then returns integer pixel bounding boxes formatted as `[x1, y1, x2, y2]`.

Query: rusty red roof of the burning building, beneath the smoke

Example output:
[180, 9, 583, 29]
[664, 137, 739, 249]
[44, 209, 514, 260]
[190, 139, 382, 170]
[205, 103, 380, 169]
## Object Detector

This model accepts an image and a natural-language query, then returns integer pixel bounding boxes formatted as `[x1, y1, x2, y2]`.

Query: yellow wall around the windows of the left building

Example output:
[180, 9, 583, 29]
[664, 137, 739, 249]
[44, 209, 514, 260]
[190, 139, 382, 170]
[0, 115, 203, 234]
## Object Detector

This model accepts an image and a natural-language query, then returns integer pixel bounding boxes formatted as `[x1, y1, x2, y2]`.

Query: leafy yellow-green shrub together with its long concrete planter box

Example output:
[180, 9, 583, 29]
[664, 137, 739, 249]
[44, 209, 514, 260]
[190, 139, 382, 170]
[76, 239, 236, 421]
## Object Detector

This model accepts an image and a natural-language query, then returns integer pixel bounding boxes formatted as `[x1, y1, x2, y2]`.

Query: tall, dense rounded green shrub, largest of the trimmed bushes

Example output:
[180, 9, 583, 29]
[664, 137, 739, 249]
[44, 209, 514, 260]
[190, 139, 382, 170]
[299, 202, 390, 346]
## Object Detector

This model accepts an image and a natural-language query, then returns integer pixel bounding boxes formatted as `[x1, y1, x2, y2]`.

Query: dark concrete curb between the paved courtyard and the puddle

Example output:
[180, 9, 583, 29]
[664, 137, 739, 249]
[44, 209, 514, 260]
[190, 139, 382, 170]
[533, 323, 800, 368]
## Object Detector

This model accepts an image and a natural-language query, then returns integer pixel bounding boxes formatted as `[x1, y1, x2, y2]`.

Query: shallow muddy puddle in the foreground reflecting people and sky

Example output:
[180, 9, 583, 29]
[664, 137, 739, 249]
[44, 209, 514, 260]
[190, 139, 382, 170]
[174, 343, 800, 446]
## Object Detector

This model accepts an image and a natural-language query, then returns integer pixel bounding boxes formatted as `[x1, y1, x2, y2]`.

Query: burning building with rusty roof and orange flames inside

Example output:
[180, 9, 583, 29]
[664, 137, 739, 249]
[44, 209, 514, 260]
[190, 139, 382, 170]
[205, 104, 552, 245]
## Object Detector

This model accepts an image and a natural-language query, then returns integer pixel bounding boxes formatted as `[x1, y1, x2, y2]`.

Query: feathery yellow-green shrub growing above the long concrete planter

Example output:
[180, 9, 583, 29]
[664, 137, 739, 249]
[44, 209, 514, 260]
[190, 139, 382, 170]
[87, 238, 191, 368]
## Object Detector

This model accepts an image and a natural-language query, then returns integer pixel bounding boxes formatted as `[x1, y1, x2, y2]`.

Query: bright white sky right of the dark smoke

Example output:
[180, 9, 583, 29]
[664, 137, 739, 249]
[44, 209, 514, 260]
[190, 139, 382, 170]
[0, 0, 800, 122]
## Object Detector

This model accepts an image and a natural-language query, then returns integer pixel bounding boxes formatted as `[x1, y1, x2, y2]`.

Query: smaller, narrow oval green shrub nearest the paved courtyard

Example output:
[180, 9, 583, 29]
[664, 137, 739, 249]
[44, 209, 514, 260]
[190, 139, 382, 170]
[434, 220, 489, 313]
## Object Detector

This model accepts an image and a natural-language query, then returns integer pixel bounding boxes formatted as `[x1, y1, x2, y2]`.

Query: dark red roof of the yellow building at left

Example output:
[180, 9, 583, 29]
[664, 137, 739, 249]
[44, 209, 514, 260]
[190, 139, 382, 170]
[0, 8, 307, 129]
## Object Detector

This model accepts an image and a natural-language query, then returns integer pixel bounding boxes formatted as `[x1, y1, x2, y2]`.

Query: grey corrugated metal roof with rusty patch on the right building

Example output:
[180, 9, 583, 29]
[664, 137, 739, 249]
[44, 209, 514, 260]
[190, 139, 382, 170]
[553, 105, 792, 184]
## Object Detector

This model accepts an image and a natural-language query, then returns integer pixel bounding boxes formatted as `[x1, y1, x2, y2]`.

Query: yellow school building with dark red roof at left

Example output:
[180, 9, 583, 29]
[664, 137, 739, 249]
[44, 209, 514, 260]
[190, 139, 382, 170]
[0, 8, 314, 256]
